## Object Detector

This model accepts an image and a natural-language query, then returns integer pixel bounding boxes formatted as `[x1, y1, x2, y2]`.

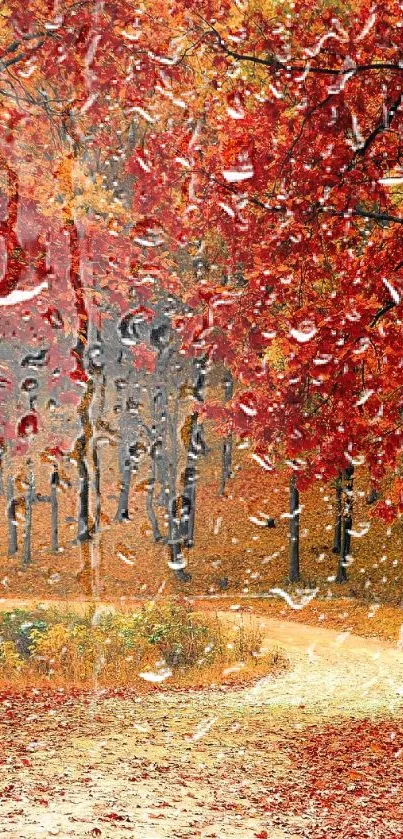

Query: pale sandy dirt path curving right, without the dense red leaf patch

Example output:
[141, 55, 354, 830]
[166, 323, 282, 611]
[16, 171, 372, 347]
[0, 612, 403, 839]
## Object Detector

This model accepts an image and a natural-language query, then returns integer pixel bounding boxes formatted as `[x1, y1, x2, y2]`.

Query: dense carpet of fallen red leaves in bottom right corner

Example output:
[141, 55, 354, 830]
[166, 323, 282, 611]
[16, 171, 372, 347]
[284, 719, 403, 839]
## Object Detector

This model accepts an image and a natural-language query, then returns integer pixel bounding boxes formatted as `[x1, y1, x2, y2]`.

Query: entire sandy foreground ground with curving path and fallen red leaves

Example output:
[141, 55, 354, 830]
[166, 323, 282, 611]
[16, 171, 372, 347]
[0, 611, 403, 839]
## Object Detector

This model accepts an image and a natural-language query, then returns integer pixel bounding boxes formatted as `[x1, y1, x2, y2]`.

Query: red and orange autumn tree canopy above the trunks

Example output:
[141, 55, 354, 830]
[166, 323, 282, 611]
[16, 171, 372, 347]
[0, 0, 403, 517]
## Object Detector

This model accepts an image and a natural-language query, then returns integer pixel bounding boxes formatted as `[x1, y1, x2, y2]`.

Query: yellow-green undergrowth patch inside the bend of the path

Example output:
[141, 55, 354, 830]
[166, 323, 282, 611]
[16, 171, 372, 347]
[0, 602, 288, 687]
